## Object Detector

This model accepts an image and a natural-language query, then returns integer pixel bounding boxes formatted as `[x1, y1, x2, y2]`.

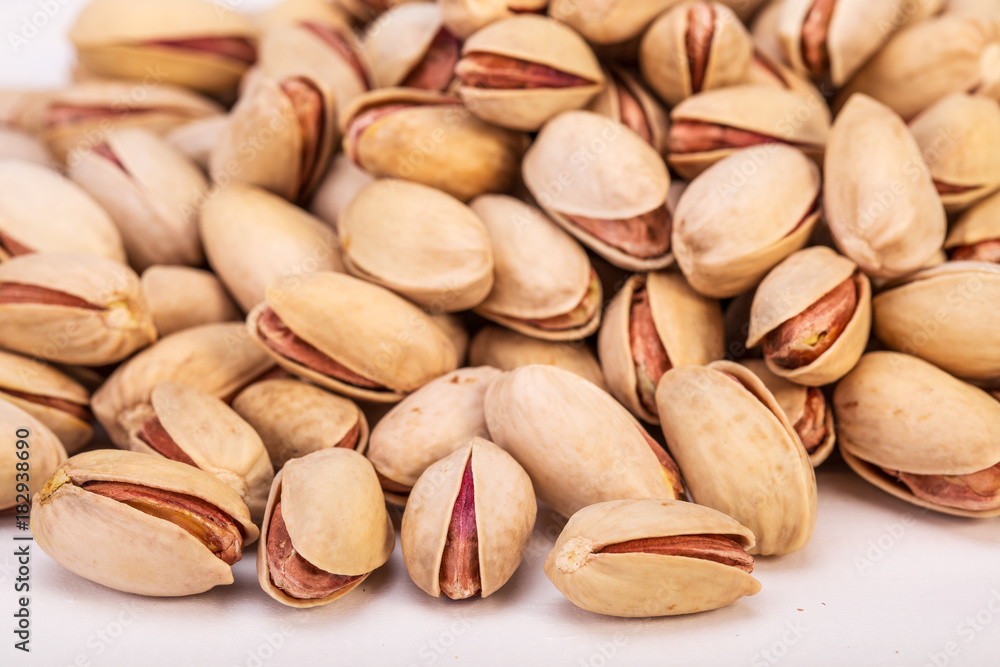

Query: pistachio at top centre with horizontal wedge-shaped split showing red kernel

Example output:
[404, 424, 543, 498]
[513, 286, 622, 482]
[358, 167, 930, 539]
[455, 14, 604, 131]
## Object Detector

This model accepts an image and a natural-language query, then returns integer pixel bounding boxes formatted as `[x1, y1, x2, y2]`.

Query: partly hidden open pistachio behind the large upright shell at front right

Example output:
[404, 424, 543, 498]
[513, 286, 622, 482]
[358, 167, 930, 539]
[740, 359, 837, 468]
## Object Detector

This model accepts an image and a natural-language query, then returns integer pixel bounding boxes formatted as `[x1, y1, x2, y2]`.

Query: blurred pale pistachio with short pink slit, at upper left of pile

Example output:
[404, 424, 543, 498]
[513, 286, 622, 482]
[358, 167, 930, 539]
[69, 128, 208, 271]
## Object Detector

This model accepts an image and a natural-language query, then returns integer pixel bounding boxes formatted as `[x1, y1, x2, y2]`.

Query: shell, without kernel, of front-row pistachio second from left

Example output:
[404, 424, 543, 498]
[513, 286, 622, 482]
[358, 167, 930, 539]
[257, 447, 396, 608]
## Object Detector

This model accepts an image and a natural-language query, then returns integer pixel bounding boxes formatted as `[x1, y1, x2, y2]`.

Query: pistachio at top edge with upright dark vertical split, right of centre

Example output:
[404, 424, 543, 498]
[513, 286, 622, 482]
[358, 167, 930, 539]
[639, 0, 753, 106]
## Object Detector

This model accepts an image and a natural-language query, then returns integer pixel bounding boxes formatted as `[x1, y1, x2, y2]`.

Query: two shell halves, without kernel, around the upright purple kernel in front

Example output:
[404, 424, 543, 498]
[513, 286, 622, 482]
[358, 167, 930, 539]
[400, 438, 537, 597]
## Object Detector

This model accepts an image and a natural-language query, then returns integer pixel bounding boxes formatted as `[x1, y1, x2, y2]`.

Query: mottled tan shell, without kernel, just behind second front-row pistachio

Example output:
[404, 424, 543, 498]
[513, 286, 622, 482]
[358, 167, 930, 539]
[233, 379, 368, 470]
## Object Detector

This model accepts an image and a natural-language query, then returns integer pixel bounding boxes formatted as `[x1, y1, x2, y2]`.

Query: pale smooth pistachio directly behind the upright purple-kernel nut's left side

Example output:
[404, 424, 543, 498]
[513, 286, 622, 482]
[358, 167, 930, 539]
[366, 366, 501, 505]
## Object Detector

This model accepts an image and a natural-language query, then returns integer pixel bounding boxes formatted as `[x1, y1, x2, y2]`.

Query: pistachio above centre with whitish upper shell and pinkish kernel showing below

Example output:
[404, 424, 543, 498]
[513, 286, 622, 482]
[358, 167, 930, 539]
[522, 111, 673, 271]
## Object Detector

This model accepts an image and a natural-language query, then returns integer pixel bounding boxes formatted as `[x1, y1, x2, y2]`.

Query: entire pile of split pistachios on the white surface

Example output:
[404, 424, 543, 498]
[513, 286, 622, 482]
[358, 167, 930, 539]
[0, 0, 1000, 617]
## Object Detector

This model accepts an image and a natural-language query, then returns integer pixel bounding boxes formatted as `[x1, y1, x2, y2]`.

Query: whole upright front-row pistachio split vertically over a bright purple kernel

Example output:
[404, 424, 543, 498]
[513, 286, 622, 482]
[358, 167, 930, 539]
[400, 438, 537, 599]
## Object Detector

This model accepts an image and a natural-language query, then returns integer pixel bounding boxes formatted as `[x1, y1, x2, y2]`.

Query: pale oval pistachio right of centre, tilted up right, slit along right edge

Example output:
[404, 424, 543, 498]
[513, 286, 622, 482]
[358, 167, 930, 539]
[672, 144, 821, 298]
